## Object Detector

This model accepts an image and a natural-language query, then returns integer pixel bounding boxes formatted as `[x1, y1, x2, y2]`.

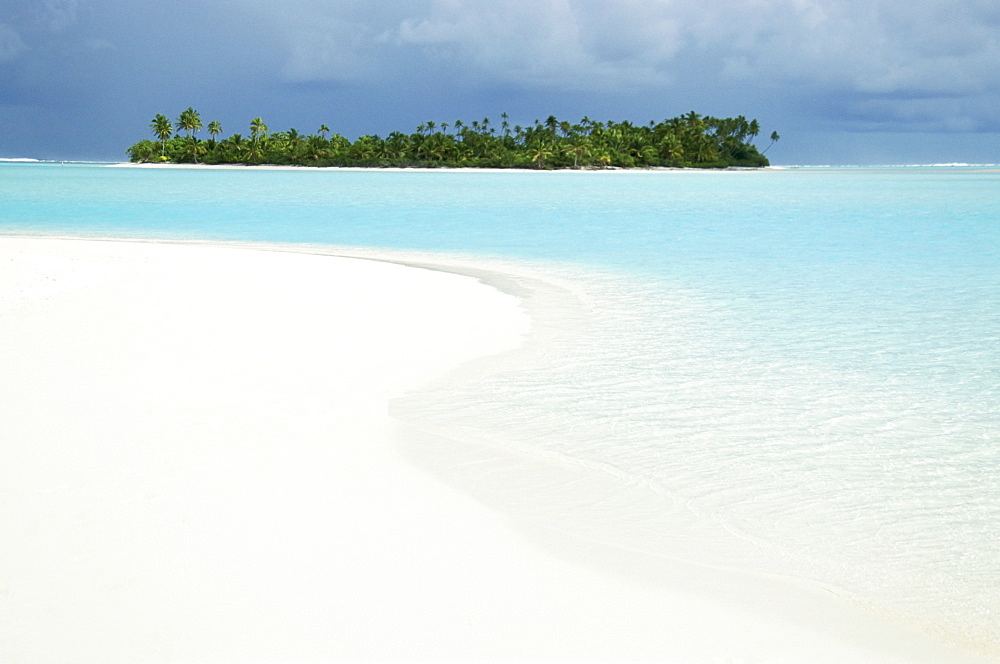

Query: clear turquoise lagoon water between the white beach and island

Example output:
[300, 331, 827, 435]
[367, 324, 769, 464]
[0, 164, 1000, 656]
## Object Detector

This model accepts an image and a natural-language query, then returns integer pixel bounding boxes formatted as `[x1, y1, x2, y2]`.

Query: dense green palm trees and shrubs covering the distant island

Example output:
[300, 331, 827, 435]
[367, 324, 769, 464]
[128, 108, 778, 169]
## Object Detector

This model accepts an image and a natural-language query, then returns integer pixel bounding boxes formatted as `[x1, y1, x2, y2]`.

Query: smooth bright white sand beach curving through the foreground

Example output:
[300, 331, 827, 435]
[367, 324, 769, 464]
[0, 238, 979, 664]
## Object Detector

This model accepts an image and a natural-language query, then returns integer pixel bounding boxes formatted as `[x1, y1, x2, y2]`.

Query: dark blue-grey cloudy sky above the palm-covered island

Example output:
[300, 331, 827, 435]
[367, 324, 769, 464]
[0, 0, 1000, 164]
